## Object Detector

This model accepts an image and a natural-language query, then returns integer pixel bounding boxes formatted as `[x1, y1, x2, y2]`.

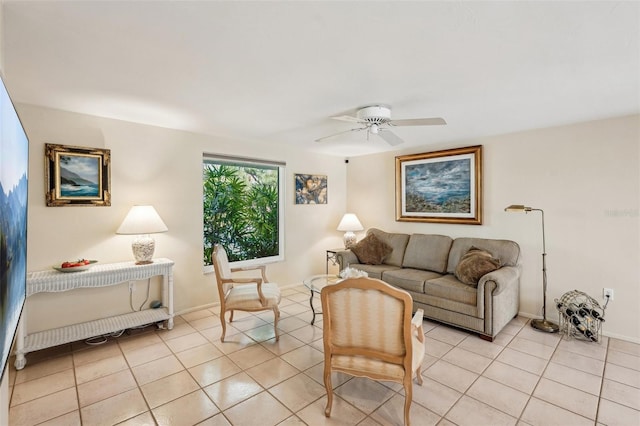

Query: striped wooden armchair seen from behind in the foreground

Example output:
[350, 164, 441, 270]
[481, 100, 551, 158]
[320, 278, 425, 426]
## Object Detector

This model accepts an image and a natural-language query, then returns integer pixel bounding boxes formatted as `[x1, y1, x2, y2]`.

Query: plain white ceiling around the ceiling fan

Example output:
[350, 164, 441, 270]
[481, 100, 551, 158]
[3, 0, 640, 156]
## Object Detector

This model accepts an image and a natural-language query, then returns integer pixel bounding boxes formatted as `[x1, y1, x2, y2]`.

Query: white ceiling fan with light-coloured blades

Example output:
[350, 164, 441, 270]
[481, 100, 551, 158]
[316, 105, 447, 145]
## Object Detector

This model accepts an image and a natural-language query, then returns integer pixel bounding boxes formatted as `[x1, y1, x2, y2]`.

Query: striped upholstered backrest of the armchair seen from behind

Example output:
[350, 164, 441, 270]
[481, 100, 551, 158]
[321, 278, 413, 364]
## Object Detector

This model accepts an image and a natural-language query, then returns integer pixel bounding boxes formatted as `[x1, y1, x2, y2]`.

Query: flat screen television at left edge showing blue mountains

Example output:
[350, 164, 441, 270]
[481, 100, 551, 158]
[0, 73, 29, 374]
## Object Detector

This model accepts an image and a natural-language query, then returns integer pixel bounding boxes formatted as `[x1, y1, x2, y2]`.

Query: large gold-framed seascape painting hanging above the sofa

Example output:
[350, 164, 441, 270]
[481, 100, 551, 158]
[396, 145, 482, 225]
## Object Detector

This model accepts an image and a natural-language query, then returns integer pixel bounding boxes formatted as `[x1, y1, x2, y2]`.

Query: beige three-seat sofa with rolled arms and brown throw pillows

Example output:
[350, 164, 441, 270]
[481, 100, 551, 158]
[336, 228, 521, 341]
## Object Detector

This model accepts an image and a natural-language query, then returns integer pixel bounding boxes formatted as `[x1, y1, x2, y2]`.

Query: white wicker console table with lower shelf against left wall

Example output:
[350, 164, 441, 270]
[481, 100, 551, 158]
[15, 259, 174, 370]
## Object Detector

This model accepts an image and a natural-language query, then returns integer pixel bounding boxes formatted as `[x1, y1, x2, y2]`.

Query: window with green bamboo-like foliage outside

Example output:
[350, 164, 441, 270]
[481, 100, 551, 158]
[202, 154, 285, 271]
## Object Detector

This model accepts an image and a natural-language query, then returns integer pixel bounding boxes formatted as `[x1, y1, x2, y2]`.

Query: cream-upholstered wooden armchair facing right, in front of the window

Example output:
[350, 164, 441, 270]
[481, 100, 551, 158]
[211, 244, 280, 342]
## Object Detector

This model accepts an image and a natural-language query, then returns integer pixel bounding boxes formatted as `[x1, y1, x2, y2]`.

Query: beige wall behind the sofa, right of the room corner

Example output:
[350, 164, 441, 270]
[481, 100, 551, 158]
[347, 115, 640, 342]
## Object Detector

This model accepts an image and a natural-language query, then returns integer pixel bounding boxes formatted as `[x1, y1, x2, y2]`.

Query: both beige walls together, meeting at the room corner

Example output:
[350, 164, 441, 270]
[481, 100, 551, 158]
[18, 105, 640, 341]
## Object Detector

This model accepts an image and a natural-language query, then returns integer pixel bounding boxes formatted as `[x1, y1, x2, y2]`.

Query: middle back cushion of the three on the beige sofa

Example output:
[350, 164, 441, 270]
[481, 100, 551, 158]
[402, 234, 453, 274]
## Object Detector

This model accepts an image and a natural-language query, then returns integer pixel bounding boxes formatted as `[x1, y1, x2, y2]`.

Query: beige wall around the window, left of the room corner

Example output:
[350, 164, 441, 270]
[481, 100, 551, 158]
[18, 105, 346, 331]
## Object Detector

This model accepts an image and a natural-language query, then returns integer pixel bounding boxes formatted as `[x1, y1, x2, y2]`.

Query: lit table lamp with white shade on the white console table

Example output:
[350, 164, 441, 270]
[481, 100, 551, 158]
[116, 206, 169, 265]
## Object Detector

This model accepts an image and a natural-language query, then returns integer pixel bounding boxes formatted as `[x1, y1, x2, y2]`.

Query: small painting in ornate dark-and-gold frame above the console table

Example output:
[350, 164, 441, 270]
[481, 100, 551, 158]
[44, 144, 111, 207]
